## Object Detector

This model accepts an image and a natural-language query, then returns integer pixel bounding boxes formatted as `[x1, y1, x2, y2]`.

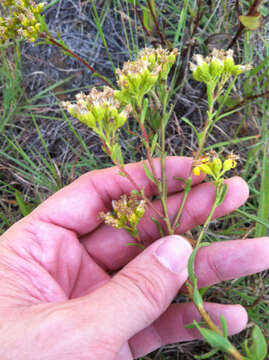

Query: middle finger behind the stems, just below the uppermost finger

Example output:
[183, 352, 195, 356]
[81, 177, 248, 270]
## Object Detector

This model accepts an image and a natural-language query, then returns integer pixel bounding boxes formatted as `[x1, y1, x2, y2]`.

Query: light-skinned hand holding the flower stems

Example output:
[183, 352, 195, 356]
[0, 157, 269, 360]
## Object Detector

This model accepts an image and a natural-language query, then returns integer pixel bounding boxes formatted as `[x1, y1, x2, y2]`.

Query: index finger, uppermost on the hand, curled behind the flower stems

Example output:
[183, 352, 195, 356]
[30, 157, 204, 235]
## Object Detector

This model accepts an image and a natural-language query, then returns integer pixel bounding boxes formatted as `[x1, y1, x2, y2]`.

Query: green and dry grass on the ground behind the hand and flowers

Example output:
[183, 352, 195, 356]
[0, 0, 269, 360]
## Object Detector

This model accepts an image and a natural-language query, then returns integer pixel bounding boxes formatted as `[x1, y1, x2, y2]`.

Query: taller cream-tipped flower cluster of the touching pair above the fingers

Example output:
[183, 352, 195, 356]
[115, 48, 177, 107]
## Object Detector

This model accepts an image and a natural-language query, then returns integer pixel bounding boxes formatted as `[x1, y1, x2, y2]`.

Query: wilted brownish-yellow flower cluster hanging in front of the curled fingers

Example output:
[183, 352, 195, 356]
[99, 194, 146, 238]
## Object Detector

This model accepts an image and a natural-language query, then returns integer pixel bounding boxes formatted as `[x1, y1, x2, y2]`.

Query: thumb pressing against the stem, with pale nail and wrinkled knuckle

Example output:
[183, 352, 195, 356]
[88, 235, 192, 343]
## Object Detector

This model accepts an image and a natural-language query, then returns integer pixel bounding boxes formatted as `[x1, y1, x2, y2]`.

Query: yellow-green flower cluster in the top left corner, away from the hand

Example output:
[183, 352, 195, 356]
[0, 0, 45, 43]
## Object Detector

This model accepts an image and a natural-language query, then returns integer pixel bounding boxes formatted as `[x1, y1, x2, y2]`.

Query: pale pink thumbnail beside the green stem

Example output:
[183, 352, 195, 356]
[154, 235, 192, 274]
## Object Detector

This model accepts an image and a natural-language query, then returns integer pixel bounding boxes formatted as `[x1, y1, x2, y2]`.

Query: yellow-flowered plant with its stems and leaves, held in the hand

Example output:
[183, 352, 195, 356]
[0, 0, 267, 360]
